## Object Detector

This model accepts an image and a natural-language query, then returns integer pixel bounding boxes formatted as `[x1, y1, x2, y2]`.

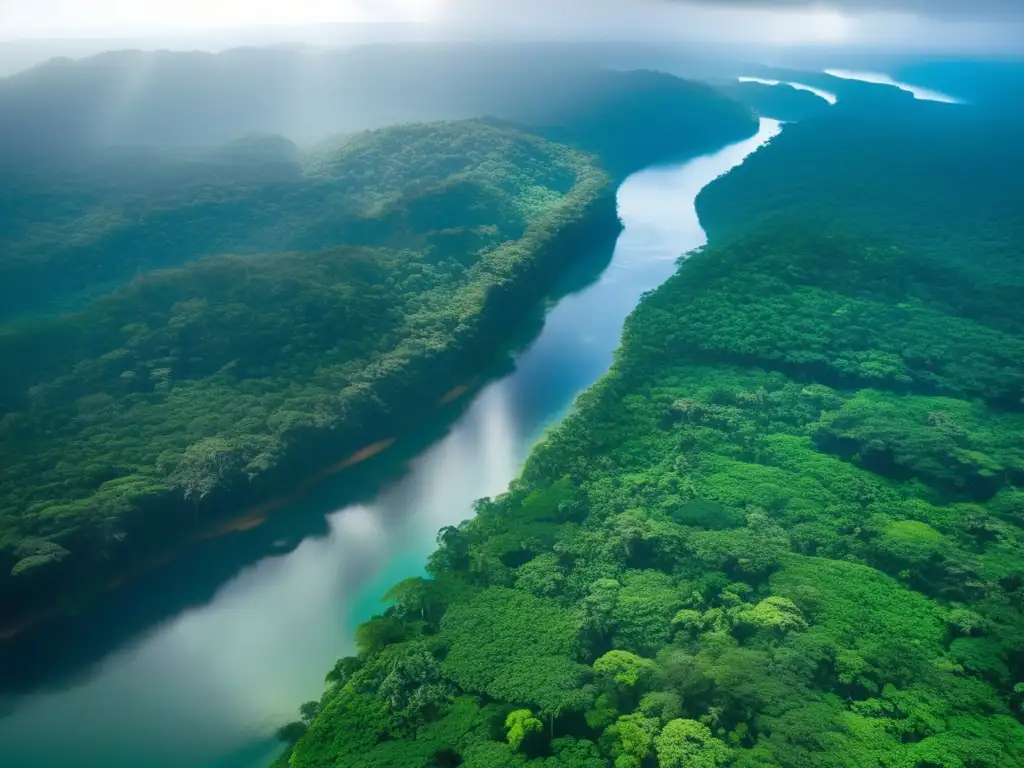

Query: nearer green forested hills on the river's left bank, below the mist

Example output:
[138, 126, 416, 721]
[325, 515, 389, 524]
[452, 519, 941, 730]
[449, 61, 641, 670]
[0, 122, 618, 626]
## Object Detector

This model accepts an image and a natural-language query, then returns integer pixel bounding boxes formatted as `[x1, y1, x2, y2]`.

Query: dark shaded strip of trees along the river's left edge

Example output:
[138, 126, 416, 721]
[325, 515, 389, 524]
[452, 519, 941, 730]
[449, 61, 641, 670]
[0, 137, 621, 636]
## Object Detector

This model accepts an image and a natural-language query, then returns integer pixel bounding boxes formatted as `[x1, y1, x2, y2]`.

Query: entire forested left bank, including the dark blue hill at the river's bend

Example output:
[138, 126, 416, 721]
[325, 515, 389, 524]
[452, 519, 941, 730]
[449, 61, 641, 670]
[0, 63, 757, 621]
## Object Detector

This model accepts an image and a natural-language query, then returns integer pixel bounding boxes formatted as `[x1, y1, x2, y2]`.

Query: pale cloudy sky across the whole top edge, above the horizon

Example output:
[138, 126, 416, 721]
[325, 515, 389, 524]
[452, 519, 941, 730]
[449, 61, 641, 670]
[0, 0, 1024, 54]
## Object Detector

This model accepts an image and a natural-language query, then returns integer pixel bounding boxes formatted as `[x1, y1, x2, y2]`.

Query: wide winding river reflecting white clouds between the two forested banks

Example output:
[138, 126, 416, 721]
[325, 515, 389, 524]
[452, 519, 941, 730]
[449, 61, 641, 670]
[0, 120, 779, 768]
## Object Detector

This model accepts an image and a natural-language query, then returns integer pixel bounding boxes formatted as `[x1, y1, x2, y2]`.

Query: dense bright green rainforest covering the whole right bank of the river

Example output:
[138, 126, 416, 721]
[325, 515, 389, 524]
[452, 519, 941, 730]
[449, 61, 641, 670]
[280, 90, 1024, 768]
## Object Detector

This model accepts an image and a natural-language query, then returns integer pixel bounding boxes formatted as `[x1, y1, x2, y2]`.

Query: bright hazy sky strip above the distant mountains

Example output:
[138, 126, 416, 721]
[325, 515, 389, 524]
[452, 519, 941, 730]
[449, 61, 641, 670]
[0, 0, 1024, 49]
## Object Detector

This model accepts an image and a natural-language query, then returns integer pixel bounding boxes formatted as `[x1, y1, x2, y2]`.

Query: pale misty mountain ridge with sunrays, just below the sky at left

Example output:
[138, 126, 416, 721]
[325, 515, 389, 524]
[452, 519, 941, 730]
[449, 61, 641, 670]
[0, 44, 753, 162]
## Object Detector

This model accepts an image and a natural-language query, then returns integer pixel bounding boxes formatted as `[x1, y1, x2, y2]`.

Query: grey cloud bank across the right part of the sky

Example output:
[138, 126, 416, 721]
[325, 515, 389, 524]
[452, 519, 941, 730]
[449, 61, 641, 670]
[425, 0, 1024, 53]
